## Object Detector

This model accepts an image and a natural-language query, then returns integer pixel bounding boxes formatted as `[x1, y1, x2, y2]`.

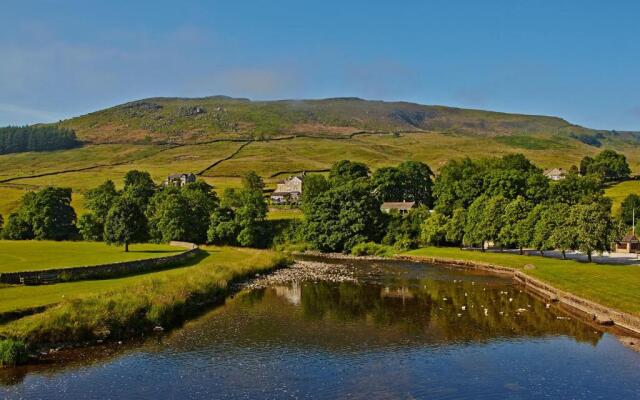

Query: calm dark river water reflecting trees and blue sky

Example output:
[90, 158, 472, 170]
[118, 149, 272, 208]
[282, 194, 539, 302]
[0, 262, 640, 399]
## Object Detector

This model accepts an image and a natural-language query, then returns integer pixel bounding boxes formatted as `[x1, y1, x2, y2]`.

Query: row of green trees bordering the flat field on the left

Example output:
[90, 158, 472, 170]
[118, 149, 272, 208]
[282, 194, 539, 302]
[0, 170, 269, 251]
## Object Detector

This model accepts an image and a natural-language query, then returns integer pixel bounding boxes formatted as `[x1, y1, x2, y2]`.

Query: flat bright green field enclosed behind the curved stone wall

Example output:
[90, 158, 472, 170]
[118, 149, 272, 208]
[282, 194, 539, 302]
[0, 240, 184, 273]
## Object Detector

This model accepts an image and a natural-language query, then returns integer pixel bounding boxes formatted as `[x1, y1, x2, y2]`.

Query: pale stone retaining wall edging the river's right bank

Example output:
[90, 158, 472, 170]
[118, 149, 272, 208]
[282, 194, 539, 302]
[394, 255, 640, 335]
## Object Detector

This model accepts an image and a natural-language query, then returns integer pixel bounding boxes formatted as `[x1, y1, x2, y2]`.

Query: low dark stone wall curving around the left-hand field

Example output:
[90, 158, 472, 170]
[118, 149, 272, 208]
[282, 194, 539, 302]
[0, 242, 200, 285]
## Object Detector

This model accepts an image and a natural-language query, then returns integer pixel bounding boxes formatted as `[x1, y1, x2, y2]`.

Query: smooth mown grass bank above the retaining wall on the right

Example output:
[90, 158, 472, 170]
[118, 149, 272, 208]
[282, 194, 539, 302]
[402, 247, 640, 315]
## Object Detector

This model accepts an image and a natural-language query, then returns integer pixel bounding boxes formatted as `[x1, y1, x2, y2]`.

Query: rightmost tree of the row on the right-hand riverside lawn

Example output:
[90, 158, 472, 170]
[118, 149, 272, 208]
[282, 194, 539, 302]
[570, 197, 615, 262]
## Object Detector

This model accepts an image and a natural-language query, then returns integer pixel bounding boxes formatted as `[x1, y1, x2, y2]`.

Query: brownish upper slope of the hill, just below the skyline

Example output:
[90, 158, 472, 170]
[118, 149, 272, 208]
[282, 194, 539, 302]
[61, 96, 632, 144]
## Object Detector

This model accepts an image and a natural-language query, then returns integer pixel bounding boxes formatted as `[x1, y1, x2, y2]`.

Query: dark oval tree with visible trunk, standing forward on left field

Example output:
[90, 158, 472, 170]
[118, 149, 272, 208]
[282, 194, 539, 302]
[104, 195, 147, 252]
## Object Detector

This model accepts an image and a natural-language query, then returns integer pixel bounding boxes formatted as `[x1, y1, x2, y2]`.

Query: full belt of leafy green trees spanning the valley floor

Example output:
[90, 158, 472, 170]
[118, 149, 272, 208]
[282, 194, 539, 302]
[0, 151, 640, 258]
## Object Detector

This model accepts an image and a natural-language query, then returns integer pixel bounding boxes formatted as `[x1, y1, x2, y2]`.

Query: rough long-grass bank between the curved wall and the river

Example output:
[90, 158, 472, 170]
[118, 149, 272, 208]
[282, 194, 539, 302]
[0, 247, 286, 344]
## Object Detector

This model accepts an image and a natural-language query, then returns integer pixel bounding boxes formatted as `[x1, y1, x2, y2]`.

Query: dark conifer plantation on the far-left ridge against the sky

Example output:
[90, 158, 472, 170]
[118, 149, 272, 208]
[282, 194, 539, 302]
[0, 126, 80, 154]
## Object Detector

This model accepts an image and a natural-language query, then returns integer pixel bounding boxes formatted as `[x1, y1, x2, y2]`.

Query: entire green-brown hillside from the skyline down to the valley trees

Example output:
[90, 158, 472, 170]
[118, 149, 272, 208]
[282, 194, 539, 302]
[0, 97, 640, 215]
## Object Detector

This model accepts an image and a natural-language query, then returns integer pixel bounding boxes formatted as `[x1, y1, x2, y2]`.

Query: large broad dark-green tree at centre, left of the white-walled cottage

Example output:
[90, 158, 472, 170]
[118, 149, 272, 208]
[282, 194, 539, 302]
[305, 180, 383, 251]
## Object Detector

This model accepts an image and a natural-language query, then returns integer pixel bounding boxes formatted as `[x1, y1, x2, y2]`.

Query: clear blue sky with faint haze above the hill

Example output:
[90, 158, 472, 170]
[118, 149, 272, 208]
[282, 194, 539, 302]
[0, 0, 640, 130]
